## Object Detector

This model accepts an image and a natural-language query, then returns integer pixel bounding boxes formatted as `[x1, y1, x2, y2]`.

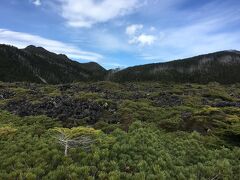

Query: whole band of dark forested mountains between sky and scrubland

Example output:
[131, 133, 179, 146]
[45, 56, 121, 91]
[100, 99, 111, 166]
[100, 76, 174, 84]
[0, 45, 240, 84]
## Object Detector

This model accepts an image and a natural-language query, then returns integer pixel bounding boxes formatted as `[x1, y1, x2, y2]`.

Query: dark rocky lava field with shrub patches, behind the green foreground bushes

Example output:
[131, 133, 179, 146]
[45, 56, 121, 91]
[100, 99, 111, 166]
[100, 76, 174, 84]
[0, 82, 240, 143]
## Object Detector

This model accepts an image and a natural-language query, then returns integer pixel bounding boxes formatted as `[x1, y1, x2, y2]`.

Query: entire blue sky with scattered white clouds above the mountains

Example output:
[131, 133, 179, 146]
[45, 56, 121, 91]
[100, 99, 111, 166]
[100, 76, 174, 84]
[0, 0, 240, 68]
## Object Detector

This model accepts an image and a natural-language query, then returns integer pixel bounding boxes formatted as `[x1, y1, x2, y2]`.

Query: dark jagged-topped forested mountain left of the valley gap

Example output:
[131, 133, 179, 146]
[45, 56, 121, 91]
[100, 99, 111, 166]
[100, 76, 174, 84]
[0, 45, 107, 84]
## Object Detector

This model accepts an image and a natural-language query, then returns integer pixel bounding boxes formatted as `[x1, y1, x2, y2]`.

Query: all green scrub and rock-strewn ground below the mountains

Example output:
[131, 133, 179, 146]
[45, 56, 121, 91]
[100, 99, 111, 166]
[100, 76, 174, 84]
[0, 82, 240, 180]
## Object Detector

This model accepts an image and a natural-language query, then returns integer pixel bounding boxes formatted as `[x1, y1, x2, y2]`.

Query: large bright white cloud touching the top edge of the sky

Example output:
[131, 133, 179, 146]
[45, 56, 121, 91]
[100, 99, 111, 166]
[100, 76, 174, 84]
[57, 0, 140, 27]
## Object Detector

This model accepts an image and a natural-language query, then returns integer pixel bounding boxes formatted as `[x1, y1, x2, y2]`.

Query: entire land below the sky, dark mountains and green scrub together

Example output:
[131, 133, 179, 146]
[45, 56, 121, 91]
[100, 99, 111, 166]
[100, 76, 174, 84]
[0, 45, 240, 180]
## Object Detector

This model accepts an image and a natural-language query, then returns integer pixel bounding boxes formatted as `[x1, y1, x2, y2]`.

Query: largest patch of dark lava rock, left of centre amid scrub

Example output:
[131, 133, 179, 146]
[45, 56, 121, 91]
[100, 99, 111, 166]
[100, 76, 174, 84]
[4, 96, 116, 124]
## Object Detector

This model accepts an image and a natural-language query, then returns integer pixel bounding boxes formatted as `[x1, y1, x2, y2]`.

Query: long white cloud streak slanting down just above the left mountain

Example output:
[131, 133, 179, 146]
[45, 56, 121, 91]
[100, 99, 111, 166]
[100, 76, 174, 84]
[0, 29, 103, 62]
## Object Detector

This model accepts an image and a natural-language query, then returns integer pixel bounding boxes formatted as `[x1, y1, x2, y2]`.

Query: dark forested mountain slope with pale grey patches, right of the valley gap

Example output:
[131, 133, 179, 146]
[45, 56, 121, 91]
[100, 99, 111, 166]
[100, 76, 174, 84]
[112, 51, 240, 84]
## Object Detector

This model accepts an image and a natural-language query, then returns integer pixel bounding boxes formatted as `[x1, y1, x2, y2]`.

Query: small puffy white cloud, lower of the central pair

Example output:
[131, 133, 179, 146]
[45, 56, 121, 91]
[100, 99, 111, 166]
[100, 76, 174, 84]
[129, 34, 157, 46]
